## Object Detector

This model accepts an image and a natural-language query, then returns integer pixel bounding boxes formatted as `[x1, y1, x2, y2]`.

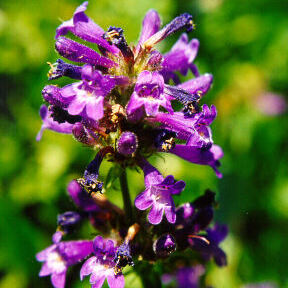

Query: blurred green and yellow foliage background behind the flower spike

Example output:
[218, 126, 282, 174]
[0, 0, 288, 288]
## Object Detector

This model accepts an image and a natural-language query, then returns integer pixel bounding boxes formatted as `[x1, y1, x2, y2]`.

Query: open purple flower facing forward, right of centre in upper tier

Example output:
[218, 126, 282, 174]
[126, 71, 173, 116]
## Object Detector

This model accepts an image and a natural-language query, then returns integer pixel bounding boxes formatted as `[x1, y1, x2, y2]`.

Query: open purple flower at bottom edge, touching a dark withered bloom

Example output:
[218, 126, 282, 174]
[80, 236, 124, 288]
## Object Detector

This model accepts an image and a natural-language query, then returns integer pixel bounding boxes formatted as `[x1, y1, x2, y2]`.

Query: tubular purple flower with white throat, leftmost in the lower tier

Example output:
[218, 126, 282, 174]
[36, 240, 93, 288]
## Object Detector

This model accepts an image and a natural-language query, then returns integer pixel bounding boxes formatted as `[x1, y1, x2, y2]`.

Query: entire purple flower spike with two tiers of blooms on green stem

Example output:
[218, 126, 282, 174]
[37, 2, 227, 288]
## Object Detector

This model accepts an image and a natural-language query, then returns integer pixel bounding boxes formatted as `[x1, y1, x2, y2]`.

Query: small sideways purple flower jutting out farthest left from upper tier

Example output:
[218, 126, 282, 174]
[36, 105, 73, 141]
